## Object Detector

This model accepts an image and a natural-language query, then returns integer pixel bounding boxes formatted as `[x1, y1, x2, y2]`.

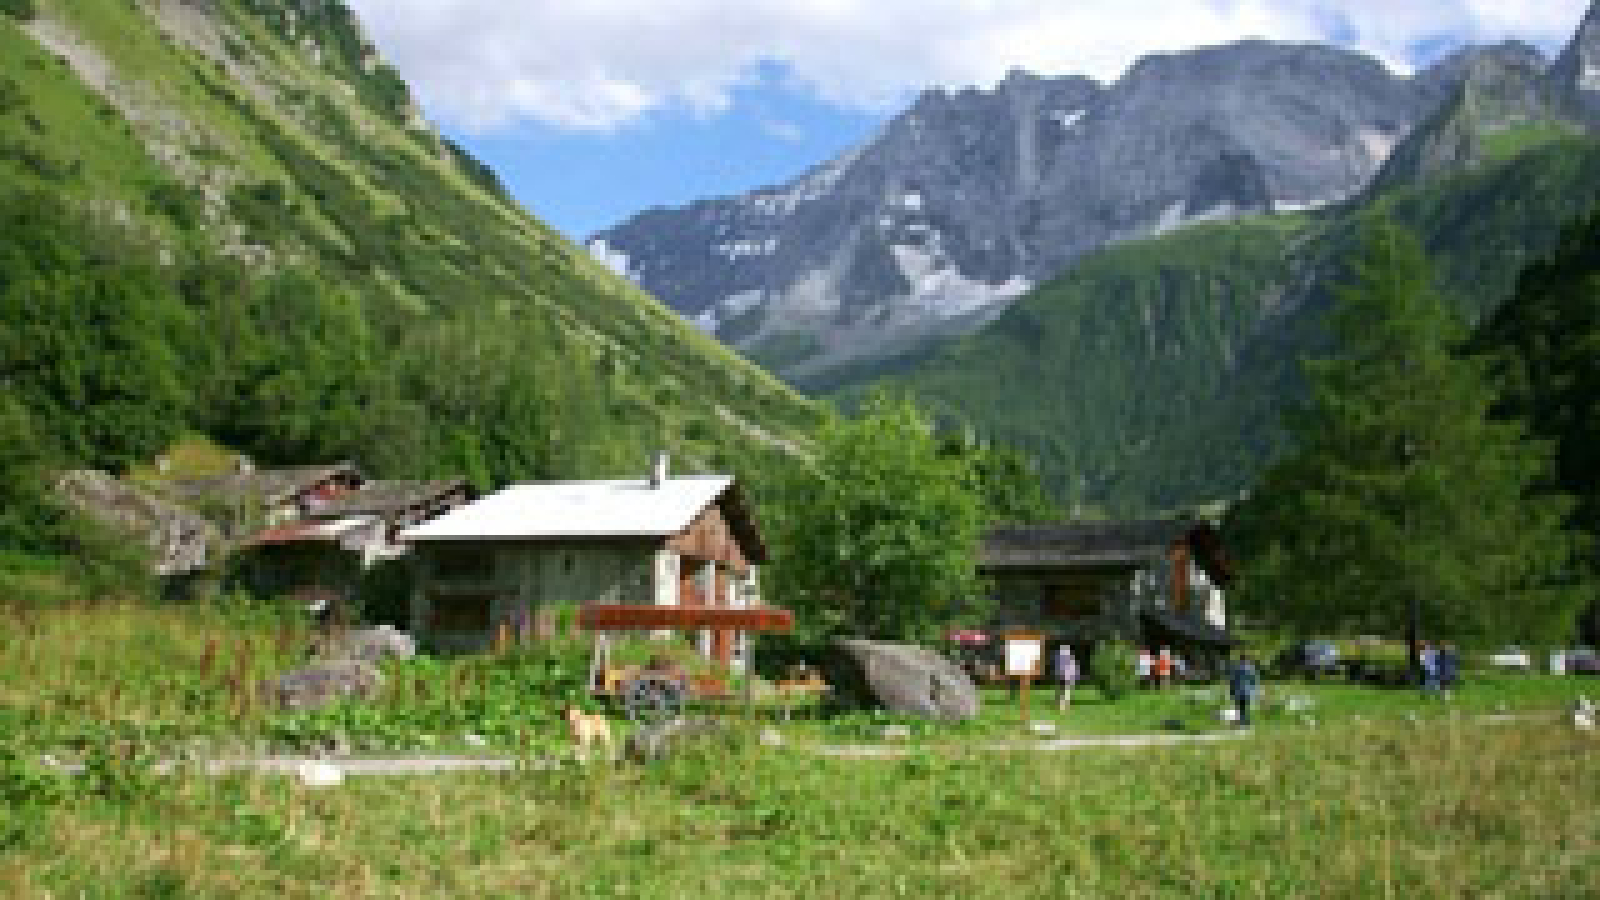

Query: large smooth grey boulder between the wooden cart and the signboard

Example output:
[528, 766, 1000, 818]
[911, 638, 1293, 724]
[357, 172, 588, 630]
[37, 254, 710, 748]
[830, 641, 982, 719]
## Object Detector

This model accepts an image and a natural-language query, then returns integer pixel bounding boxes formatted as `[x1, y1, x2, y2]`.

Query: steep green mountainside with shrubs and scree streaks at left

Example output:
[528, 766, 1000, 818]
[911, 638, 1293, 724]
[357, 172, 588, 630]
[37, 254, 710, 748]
[0, 0, 819, 482]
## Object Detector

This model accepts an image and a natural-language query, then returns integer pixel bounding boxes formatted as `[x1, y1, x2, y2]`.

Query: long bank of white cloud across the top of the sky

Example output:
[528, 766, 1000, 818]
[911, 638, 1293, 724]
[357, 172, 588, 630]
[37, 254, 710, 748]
[349, 0, 1587, 131]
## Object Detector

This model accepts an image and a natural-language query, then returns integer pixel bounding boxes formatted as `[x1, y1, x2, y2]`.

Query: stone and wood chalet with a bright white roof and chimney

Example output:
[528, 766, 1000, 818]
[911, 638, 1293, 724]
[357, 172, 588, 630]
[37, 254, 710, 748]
[400, 463, 766, 665]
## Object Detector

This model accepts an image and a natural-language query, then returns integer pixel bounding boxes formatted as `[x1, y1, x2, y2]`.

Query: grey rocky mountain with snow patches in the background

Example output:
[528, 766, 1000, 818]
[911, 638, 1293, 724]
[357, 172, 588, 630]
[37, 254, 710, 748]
[589, 40, 1542, 386]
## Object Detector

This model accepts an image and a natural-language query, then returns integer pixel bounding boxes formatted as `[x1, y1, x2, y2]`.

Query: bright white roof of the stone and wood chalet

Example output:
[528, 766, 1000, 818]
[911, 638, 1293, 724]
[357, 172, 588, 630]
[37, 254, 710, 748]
[400, 476, 733, 541]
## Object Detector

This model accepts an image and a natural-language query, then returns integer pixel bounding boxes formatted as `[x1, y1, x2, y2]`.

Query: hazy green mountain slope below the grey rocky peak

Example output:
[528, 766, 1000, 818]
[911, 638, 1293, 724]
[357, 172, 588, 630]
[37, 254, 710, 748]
[888, 127, 1600, 511]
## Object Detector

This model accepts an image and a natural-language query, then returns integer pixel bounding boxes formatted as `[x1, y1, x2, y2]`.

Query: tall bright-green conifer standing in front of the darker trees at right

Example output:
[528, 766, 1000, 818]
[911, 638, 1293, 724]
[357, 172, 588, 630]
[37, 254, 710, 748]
[1234, 219, 1578, 644]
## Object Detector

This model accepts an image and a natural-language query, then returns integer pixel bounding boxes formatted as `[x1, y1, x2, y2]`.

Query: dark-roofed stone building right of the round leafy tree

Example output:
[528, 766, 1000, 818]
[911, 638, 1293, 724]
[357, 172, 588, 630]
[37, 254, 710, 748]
[979, 519, 1234, 649]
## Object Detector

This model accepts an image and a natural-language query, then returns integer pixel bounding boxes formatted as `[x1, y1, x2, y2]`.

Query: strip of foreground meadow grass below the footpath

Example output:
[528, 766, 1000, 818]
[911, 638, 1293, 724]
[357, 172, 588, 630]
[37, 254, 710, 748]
[0, 717, 1600, 898]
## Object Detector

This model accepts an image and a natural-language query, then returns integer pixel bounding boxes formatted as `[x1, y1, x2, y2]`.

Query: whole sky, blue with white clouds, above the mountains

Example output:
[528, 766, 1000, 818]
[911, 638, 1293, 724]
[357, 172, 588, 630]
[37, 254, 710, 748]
[349, 0, 1587, 239]
